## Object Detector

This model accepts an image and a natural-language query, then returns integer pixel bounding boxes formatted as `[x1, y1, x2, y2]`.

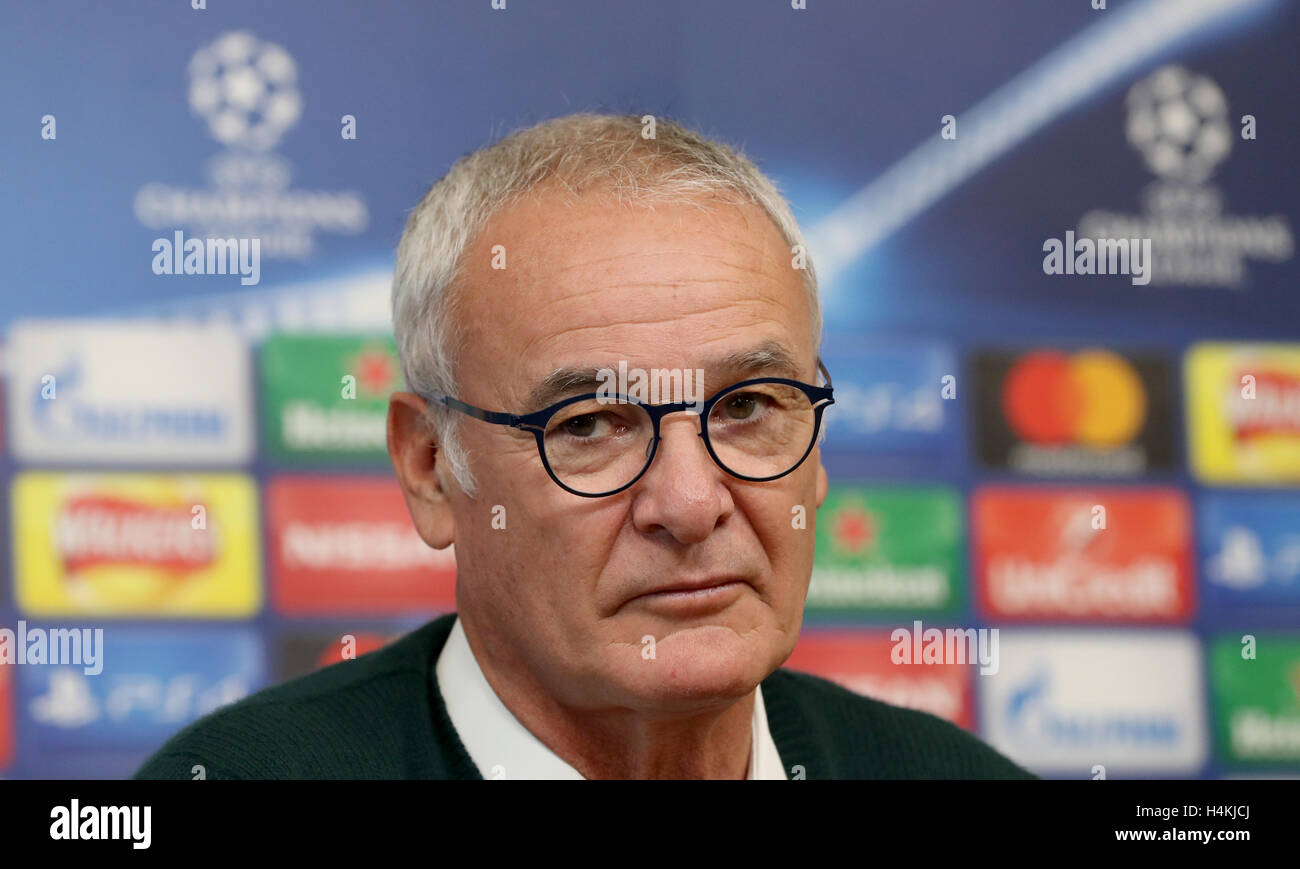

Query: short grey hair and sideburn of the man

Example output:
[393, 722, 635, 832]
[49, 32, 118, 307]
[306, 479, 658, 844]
[393, 113, 822, 496]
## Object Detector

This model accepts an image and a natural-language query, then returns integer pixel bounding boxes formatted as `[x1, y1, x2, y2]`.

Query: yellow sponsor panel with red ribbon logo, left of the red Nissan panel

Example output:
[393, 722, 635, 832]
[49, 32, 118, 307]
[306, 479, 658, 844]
[13, 472, 261, 618]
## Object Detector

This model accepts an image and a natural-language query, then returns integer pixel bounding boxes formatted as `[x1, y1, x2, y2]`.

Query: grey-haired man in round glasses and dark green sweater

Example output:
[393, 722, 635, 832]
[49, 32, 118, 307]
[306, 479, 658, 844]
[138, 114, 1030, 779]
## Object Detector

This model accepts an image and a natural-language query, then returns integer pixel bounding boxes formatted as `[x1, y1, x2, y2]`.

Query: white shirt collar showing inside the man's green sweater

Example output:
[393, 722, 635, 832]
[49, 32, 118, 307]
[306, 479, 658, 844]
[436, 618, 785, 781]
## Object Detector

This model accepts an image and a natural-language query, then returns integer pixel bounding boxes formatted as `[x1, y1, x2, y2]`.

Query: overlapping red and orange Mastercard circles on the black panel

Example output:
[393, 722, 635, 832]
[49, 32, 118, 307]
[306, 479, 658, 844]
[1001, 350, 1147, 449]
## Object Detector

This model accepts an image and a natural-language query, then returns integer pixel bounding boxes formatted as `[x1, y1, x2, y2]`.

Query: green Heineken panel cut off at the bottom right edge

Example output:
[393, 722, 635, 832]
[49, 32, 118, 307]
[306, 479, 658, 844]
[1210, 634, 1300, 765]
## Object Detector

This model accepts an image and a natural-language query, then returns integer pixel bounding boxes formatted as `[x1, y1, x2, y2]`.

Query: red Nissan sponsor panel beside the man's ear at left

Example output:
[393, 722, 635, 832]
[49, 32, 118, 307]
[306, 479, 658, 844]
[267, 477, 456, 615]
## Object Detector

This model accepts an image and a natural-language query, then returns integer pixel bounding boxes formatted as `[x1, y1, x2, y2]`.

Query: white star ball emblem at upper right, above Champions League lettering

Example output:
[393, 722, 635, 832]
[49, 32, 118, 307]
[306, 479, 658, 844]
[1126, 66, 1232, 183]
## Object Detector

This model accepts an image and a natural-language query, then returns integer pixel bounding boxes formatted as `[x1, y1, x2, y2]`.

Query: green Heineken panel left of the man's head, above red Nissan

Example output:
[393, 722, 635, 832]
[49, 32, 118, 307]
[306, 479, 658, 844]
[261, 334, 402, 461]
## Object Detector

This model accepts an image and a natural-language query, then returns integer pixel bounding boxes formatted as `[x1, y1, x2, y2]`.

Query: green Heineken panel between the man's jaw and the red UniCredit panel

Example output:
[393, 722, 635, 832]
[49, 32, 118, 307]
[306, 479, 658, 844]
[807, 487, 962, 613]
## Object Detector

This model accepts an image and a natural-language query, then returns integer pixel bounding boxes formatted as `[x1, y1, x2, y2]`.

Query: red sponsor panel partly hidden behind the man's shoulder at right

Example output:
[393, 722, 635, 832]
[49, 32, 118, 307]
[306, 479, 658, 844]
[784, 631, 978, 730]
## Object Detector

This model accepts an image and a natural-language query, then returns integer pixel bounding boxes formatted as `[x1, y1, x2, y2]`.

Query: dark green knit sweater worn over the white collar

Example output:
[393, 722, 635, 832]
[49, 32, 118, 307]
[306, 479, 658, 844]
[135, 614, 1034, 779]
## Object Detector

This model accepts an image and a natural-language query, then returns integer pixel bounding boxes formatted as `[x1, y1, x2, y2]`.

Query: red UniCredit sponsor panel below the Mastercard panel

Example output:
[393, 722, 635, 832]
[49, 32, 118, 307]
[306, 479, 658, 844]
[971, 487, 1195, 622]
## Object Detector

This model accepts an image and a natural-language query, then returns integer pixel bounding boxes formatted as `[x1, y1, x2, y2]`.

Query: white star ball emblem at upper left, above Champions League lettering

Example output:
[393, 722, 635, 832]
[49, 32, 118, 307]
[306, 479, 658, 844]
[190, 30, 303, 151]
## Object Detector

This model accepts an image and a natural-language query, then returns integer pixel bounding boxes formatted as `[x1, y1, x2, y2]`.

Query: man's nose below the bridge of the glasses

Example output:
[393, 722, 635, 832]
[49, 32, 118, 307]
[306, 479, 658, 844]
[632, 412, 736, 544]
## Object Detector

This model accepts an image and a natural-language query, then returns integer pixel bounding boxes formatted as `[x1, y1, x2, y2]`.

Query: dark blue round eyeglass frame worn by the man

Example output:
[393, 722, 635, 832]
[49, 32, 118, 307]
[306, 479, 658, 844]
[417, 356, 835, 498]
